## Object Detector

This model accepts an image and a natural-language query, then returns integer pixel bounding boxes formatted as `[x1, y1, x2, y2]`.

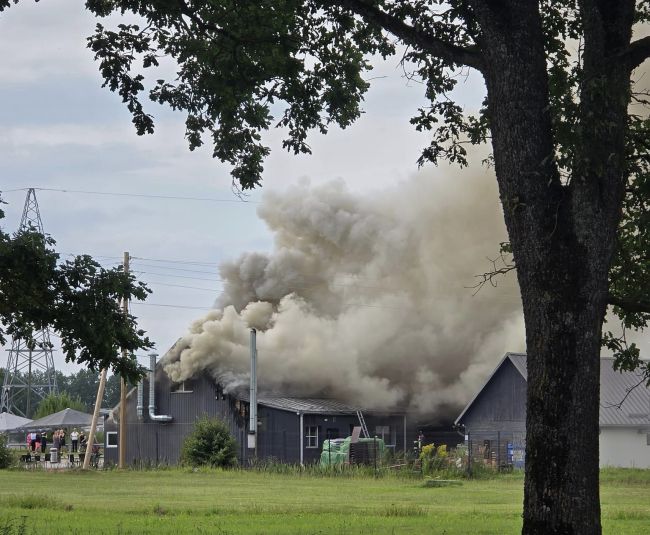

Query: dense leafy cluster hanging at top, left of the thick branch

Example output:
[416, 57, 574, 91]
[86, 0, 394, 189]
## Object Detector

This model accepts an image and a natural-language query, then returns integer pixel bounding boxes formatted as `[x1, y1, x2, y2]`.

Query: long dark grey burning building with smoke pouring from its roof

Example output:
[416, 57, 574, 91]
[105, 365, 406, 465]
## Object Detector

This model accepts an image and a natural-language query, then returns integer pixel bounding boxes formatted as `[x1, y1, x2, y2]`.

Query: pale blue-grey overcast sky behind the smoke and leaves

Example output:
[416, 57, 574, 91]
[0, 0, 640, 371]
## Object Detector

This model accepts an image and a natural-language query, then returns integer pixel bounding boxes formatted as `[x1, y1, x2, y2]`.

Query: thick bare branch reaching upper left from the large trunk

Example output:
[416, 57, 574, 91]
[323, 0, 483, 71]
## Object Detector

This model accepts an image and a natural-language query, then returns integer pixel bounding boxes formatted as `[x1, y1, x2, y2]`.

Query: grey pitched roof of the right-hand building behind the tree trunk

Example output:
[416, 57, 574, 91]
[455, 353, 650, 427]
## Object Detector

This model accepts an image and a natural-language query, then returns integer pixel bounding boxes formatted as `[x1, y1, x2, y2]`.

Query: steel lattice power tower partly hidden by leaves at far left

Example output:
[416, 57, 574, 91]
[0, 188, 58, 418]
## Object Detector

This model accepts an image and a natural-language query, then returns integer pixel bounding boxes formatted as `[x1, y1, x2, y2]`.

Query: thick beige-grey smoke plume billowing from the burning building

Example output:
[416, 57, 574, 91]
[165, 169, 524, 415]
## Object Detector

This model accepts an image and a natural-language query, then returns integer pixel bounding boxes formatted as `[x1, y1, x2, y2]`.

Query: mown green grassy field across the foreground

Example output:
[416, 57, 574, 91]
[0, 469, 650, 535]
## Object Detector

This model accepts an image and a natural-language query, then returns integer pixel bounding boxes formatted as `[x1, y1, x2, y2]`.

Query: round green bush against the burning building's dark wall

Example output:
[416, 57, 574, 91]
[181, 416, 237, 467]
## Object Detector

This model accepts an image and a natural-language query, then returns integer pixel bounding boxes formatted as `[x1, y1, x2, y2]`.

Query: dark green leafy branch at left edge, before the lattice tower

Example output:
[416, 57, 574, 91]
[0, 195, 153, 380]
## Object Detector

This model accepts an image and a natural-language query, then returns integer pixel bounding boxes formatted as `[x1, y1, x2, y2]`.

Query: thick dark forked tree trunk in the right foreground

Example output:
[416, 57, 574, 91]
[473, 0, 633, 535]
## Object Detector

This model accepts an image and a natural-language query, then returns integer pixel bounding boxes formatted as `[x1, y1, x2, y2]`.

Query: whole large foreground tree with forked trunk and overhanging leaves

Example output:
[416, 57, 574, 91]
[0, 0, 650, 534]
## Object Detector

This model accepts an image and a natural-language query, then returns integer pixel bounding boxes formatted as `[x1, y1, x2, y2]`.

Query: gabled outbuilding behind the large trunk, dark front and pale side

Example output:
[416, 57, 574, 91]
[455, 353, 650, 468]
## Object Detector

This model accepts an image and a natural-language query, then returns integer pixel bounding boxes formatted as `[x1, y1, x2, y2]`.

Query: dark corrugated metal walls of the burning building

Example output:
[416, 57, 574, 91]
[105, 368, 404, 466]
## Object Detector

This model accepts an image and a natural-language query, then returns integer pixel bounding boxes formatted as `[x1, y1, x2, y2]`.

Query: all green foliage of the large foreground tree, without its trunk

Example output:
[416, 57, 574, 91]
[72, 0, 650, 382]
